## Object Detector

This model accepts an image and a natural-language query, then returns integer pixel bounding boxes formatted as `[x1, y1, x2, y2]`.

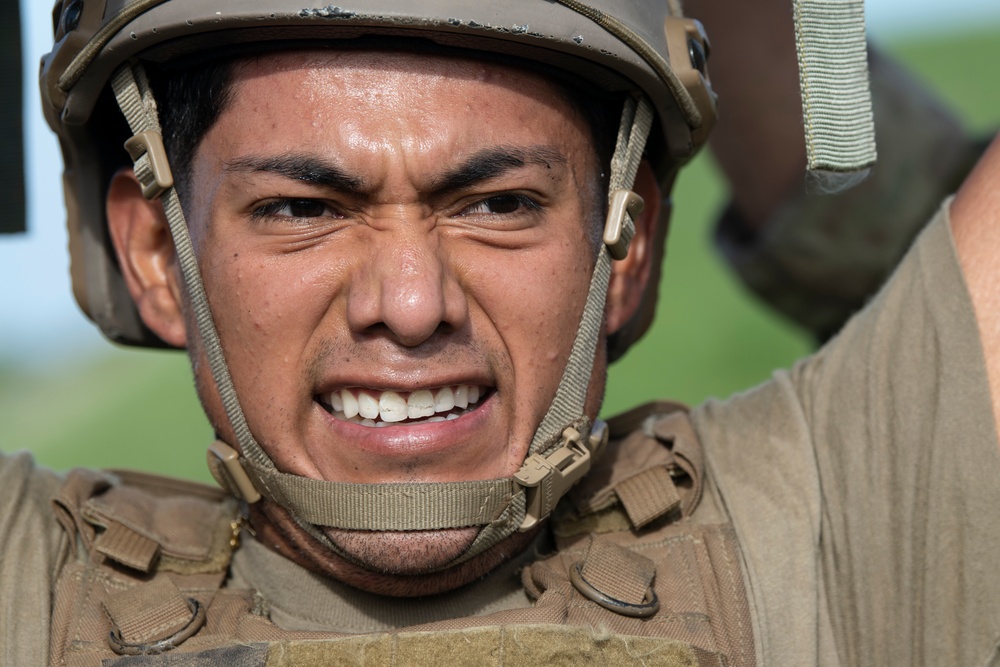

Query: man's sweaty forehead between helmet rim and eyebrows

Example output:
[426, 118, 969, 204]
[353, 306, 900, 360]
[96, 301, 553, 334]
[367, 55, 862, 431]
[215, 50, 589, 153]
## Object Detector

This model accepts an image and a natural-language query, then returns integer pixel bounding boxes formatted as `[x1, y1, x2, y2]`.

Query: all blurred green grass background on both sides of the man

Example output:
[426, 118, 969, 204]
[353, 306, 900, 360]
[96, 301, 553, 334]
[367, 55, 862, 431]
[0, 30, 1000, 480]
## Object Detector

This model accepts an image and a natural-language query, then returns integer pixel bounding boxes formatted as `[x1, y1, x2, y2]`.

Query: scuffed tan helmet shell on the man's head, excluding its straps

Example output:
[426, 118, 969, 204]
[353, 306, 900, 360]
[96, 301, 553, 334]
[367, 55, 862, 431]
[41, 0, 715, 351]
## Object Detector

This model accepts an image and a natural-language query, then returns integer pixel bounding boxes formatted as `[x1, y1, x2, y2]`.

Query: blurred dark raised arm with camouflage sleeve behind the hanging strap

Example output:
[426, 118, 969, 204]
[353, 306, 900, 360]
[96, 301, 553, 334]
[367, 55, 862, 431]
[685, 0, 983, 340]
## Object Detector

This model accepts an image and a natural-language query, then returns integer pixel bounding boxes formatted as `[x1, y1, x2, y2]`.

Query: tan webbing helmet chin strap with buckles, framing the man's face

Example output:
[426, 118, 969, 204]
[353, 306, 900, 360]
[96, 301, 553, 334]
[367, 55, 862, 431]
[112, 63, 653, 569]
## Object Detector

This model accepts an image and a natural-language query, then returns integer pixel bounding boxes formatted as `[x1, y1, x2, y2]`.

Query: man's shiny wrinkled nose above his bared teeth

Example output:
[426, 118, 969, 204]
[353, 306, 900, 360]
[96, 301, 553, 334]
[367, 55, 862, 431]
[347, 225, 468, 347]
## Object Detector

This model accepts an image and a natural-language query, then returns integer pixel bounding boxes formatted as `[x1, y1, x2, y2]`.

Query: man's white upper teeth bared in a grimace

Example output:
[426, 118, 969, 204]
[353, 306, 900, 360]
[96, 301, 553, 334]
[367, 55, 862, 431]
[322, 384, 482, 423]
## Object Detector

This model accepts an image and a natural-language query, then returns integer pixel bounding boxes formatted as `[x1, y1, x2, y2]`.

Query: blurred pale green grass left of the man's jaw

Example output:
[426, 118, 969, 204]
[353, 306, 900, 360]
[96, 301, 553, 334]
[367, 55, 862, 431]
[0, 349, 212, 481]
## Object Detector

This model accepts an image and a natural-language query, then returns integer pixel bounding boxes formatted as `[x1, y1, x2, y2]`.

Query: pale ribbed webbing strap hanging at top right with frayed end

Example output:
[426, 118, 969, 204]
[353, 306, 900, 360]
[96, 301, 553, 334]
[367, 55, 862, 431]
[793, 0, 876, 192]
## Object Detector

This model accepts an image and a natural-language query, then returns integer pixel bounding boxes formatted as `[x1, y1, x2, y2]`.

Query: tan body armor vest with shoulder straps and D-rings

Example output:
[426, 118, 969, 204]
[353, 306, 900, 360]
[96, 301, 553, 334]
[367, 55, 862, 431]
[50, 403, 755, 667]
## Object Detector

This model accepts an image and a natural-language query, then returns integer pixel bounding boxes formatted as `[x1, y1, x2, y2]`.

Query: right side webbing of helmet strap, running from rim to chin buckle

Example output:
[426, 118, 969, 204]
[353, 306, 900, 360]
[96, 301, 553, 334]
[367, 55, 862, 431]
[529, 97, 653, 454]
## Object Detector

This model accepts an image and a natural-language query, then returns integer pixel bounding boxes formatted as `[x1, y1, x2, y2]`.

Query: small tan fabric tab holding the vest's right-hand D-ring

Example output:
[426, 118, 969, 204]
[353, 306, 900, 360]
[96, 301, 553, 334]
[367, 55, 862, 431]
[581, 537, 656, 605]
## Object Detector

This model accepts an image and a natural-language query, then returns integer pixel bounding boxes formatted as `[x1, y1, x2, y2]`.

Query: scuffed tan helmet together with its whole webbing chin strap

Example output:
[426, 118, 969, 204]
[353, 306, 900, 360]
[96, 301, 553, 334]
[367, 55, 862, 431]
[41, 0, 715, 567]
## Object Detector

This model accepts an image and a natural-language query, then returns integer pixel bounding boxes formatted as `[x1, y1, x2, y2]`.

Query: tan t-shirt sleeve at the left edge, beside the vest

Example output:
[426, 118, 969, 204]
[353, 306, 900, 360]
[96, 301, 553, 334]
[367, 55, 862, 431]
[0, 453, 63, 667]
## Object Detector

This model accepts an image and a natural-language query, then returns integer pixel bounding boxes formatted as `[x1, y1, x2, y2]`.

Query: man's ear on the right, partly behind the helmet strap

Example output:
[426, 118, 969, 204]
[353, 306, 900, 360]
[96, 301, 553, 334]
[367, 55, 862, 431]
[606, 160, 661, 334]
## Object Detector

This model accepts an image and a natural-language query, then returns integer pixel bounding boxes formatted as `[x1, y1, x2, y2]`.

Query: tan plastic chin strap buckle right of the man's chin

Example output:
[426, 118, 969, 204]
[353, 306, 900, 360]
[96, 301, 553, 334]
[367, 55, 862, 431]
[514, 420, 608, 533]
